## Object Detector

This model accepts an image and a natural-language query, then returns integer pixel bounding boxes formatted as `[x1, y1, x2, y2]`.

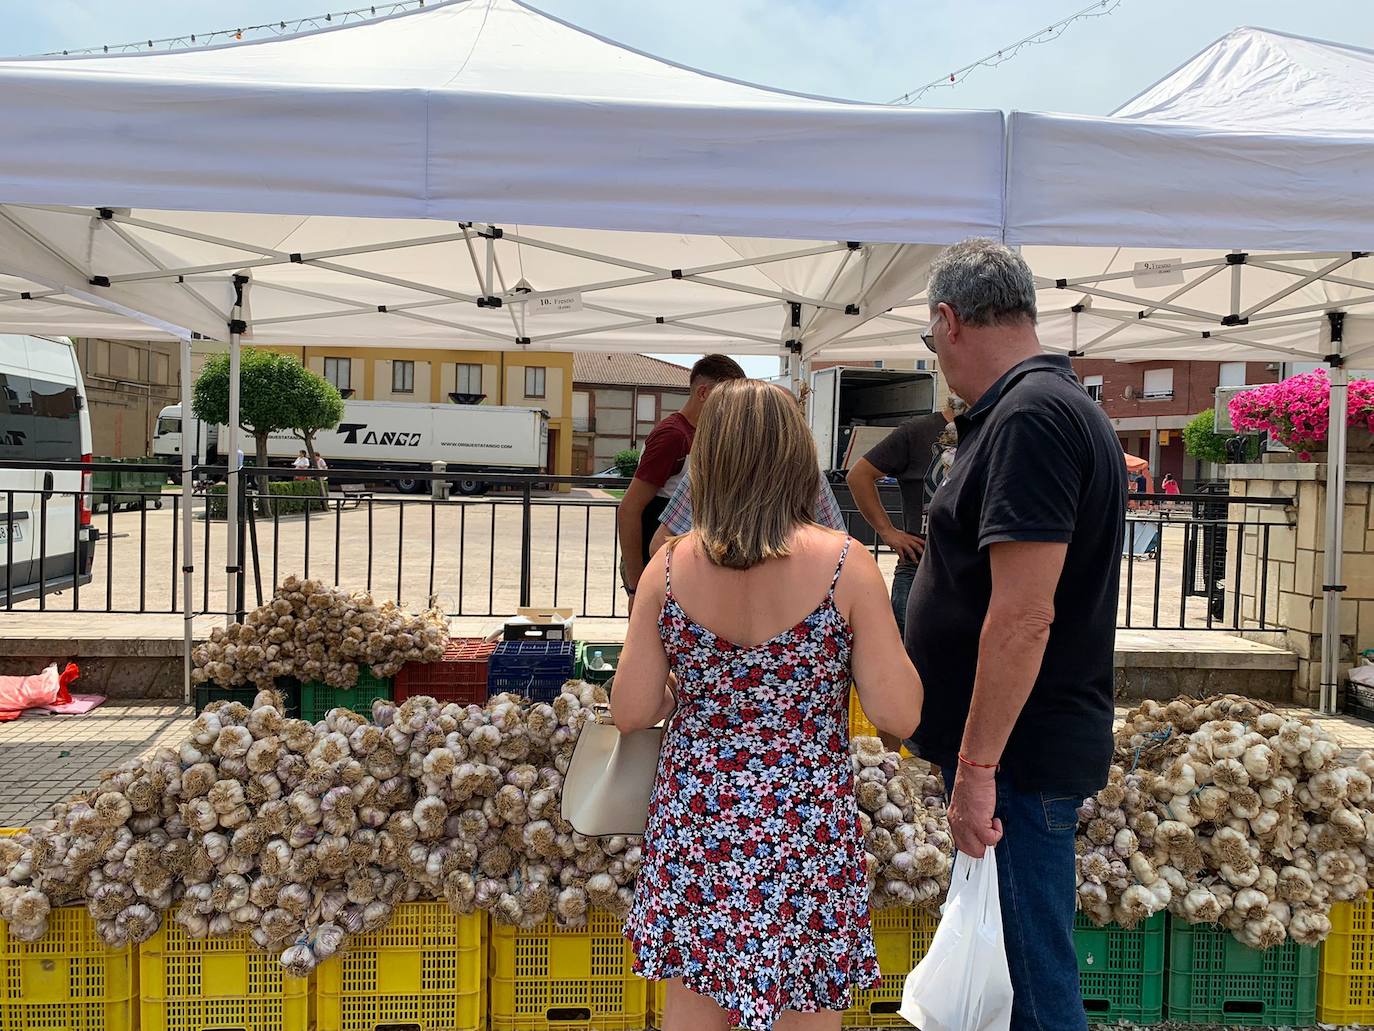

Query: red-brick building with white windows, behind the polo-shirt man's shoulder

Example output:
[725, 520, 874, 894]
[1073, 359, 1281, 483]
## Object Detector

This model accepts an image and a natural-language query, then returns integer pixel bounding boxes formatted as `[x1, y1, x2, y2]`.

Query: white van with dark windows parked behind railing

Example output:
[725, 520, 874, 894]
[0, 334, 96, 609]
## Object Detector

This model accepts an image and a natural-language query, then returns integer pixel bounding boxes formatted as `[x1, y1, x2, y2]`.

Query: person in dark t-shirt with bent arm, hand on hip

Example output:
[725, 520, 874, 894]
[845, 395, 966, 631]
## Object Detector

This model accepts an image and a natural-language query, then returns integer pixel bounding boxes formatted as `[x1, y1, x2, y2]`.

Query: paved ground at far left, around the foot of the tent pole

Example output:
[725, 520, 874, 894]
[0, 702, 191, 828]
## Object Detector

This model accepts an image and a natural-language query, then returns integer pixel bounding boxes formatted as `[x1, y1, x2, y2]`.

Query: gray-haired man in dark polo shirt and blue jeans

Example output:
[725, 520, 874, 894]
[905, 241, 1125, 1031]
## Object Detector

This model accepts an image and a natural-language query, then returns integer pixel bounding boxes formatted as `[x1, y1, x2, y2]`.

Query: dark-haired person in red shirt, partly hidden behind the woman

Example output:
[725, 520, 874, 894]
[616, 355, 746, 609]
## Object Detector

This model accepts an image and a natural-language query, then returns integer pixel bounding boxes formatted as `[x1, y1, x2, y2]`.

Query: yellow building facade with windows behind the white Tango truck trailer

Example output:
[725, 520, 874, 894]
[264, 345, 573, 476]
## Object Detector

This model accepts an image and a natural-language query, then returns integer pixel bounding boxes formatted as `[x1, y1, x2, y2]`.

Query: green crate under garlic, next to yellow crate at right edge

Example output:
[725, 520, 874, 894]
[1168, 917, 1318, 1027]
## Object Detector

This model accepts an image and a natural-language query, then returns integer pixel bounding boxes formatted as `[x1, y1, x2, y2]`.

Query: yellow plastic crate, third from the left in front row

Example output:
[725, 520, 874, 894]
[315, 902, 486, 1031]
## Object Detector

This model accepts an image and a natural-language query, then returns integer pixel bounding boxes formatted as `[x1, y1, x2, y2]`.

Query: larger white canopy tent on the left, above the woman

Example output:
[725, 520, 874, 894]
[0, 0, 1004, 703]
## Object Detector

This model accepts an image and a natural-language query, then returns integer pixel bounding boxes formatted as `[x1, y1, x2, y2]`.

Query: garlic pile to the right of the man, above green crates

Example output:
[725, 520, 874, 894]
[1077, 696, 1374, 949]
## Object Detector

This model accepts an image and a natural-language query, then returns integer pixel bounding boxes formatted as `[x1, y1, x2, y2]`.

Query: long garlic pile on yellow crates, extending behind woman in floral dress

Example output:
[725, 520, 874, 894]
[0, 682, 951, 976]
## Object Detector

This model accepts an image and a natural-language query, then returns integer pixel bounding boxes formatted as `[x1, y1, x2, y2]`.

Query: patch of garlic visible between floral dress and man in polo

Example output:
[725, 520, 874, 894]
[849, 737, 954, 909]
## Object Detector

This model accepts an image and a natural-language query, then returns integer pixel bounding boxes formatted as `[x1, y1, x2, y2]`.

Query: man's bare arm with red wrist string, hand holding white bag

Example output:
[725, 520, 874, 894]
[949, 540, 1069, 859]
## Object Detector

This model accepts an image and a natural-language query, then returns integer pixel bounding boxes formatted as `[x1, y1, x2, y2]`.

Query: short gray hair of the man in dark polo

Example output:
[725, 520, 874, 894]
[926, 239, 1036, 326]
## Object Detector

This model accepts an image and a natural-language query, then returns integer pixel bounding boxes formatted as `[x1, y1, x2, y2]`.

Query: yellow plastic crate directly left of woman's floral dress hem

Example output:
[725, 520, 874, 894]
[491, 913, 649, 1031]
